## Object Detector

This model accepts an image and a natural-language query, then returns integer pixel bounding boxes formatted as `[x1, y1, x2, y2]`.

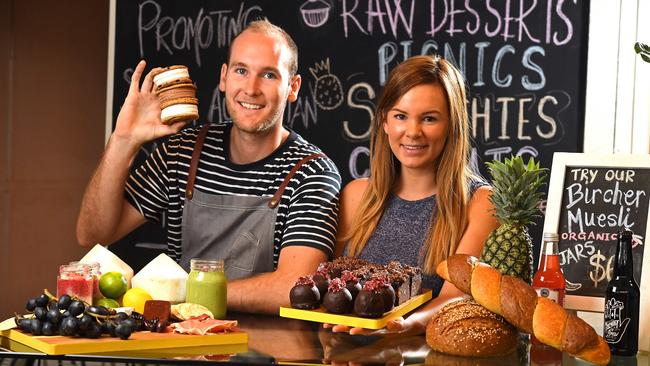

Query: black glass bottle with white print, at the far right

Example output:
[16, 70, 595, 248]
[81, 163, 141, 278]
[603, 229, 641, 356]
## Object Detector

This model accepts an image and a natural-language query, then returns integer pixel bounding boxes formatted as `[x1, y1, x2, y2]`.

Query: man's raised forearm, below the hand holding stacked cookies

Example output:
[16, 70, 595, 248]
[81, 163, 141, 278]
[77, 136, 138, 245]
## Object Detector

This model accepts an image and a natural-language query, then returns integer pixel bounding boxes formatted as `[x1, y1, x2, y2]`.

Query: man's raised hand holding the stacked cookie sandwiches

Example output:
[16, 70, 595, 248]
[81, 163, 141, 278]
[113, 60, 185, 148]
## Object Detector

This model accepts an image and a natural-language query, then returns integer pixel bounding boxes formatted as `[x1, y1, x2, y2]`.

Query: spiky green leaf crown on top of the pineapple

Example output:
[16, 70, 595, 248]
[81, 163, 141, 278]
[486, 156, 547, 225]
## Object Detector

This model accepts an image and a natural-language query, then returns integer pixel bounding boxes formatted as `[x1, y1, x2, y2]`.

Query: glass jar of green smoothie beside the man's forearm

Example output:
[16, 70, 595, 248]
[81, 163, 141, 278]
[185, 258, 227, 319]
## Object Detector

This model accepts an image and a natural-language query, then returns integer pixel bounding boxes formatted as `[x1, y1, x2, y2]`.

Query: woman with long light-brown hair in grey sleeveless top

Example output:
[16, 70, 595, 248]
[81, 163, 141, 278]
[326, 56, 497, 334]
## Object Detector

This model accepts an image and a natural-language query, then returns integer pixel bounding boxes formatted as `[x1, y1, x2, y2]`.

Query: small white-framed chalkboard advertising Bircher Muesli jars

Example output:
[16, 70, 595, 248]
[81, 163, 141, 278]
[544, 154, 650, 311]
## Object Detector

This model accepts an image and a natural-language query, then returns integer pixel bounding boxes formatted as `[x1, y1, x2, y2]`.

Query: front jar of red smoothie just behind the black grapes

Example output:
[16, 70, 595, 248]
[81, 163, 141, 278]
[56, 262, 95, 304]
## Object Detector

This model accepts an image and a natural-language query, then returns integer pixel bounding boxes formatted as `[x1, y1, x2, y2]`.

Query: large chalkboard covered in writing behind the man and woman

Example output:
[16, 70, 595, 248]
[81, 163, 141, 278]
[107, 0, 589, 264]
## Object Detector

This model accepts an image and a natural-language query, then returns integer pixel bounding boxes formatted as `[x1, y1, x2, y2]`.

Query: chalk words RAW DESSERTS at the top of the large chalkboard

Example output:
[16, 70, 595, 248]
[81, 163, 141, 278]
[340, 0, 579, 46]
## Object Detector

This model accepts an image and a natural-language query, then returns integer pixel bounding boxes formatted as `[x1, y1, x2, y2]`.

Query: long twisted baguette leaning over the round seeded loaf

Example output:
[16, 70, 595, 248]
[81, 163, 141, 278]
[436, 254, 610, 365]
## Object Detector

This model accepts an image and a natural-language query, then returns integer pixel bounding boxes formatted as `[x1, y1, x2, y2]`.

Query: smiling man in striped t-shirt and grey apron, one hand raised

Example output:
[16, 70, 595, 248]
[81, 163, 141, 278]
[77, 20, 341, 314]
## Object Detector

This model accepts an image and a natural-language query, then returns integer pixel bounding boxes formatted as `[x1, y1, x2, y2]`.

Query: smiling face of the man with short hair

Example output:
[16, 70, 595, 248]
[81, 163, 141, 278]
[219, 31, 300, 133]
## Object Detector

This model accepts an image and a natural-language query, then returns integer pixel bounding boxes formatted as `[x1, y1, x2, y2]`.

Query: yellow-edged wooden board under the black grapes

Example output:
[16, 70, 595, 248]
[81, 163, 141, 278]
[0, 329, 248, 355]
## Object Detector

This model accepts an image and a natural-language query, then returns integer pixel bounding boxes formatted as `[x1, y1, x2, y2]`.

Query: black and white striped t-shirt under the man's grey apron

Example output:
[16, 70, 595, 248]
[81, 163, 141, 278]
[125, 123, 341, 267]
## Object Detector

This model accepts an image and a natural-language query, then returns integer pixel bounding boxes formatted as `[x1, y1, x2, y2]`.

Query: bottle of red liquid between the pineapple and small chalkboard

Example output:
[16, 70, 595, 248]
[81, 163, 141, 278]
[533, 233, 566, 306]
